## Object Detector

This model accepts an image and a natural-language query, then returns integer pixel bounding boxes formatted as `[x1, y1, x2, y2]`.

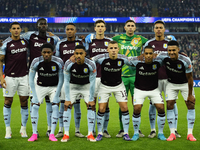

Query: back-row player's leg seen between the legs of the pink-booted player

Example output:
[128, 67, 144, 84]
[45, 96, 52, 136]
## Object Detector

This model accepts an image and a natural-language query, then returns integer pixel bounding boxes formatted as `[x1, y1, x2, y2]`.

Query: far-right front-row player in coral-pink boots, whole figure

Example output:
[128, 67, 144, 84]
[160, 40, 196, 141]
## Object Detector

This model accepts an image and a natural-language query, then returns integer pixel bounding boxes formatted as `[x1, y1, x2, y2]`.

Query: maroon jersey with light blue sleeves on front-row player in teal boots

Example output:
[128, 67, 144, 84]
[130, 57, 162, 91]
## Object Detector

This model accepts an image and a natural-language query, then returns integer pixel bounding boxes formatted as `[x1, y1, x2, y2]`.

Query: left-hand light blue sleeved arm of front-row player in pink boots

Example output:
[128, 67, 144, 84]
[29, 58, 39, 104]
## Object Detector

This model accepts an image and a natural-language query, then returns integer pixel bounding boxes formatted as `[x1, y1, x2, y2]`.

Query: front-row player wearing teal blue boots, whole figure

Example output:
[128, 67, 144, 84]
[130, 46, 166, 141]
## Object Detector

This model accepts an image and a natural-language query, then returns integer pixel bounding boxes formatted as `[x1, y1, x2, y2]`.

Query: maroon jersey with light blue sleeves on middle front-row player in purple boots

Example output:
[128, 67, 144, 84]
[92, 53, 131, 86]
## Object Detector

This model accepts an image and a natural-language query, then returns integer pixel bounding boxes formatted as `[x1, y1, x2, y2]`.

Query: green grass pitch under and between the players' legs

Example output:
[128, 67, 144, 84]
[0, 88, 200, 150]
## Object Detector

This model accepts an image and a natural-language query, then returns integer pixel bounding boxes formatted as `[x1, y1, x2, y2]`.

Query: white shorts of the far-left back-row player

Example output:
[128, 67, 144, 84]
[3, 75, 29, 97]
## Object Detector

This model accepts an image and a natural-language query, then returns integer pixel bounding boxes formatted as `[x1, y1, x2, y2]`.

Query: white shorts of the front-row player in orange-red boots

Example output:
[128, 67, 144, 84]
[70, 83, 90, 104]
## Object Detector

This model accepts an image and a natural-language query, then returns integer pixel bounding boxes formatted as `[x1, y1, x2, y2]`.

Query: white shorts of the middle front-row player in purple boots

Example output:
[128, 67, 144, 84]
[98, 82, 128, 103]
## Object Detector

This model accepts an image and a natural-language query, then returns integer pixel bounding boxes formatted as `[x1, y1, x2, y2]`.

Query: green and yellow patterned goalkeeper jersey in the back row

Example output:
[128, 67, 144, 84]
[112, 34, 148, 76]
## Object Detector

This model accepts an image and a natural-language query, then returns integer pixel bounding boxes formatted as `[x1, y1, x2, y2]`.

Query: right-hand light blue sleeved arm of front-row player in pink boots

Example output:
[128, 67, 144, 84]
[53, 61, 64, 103]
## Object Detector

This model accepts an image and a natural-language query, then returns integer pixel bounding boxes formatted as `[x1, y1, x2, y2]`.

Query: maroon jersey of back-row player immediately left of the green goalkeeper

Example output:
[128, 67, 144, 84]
[86, 37, 112, 77]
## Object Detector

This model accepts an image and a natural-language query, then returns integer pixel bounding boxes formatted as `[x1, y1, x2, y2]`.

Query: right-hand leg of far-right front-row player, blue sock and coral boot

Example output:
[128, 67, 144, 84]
[181, 84, 196, 141]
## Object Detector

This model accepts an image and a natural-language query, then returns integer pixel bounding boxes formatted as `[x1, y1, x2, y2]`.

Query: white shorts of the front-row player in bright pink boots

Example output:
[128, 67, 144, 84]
[35, 84, 57, 104]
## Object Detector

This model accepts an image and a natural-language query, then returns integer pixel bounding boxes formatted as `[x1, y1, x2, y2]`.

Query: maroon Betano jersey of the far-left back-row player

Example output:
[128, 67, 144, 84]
[0, 37, 28, 77]
